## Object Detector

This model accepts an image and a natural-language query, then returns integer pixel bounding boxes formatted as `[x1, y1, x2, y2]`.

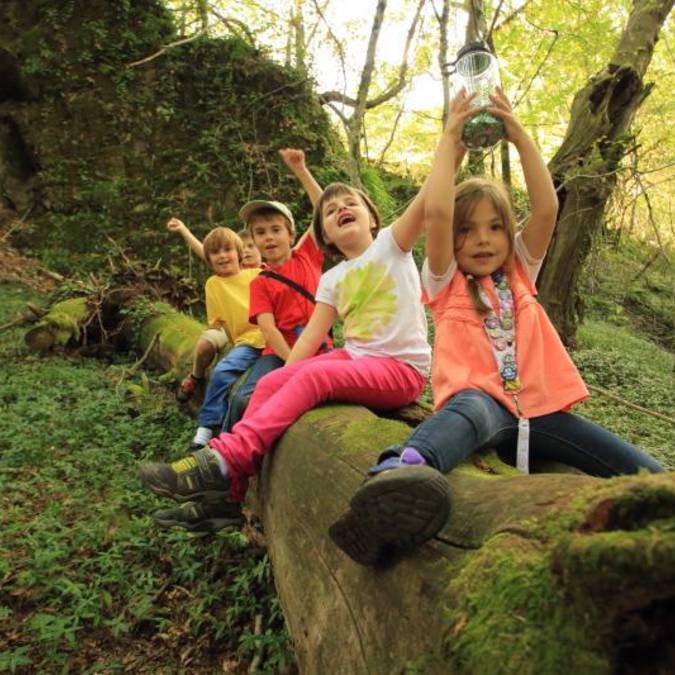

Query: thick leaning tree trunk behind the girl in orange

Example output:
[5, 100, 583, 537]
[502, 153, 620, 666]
[538, 0, 673, 344]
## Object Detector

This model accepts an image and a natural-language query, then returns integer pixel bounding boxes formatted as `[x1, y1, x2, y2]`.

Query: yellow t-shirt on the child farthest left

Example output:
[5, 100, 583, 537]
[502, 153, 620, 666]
[205, 268, 265, 348]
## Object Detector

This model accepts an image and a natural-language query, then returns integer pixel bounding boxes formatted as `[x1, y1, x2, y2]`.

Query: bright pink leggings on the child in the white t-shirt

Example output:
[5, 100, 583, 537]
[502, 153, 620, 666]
[209, 349, 424, 501]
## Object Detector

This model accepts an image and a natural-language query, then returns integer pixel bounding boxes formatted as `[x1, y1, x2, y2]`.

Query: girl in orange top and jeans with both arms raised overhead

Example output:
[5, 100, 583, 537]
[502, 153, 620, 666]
[330, 90, 663, 565]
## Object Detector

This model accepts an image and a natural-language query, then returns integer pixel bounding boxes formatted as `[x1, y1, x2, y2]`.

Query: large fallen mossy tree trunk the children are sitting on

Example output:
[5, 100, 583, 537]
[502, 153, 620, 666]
[120, 302, 675, 674]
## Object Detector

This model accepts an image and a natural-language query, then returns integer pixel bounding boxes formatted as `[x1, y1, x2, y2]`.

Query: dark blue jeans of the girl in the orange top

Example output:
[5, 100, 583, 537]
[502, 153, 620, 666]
[380, 389, 664, 477]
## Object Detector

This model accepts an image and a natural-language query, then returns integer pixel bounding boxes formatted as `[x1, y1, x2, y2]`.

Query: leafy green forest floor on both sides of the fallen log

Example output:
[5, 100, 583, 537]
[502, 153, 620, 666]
[0, 236, 675, 673]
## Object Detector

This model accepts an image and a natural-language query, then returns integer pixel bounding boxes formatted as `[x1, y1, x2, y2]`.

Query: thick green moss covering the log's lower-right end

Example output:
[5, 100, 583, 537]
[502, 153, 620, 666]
[445, 475, 675, 673]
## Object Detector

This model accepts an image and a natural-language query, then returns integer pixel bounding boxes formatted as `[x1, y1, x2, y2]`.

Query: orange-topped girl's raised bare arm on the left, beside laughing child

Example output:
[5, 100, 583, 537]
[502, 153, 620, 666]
[424, 90, 479, 276]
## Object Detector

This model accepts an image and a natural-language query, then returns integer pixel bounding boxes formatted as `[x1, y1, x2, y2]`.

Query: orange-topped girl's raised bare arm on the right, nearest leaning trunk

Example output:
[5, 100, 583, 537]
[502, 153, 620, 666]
[489, 89, 558, 258]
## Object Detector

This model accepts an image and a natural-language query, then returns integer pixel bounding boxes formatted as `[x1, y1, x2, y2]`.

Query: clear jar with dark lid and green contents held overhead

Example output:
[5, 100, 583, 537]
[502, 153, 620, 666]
[455, 41, 506, 150]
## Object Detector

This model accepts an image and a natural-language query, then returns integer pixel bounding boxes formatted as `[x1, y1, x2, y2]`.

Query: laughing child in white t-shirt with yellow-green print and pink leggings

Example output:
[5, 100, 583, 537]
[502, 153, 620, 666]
[141, 148, 460, 529]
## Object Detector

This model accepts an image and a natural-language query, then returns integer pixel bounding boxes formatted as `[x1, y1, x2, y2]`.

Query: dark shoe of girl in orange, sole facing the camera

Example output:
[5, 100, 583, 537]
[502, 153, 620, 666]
[328, 462, 450, 565]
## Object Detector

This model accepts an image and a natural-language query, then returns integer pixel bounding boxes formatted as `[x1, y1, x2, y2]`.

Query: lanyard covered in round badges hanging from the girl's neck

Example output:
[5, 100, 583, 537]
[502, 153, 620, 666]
[477, 270, 530, 473]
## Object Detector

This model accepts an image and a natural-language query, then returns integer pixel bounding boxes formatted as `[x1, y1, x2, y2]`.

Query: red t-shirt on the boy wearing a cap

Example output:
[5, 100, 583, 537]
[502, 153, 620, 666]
[249, 236, 332, 354]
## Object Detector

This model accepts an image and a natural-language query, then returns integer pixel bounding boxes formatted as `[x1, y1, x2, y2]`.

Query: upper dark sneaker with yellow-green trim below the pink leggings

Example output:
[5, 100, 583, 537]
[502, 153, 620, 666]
[140, 448, 230, 502]
